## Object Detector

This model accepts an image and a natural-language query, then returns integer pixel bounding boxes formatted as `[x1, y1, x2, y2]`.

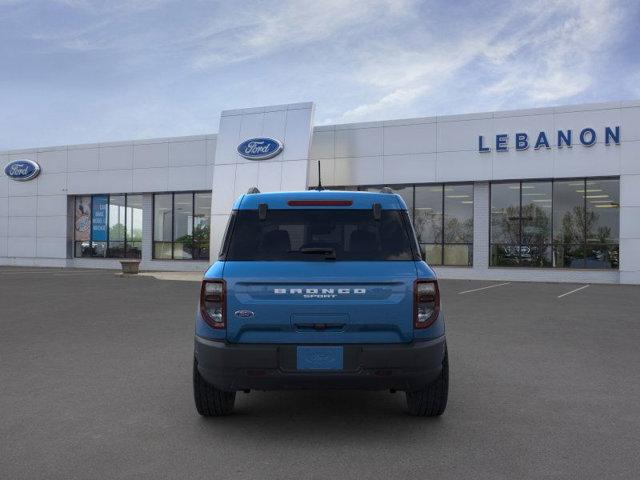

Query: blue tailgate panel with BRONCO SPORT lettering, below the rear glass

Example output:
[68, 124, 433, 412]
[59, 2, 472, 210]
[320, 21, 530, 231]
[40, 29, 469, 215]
[224, 261, 416, 344]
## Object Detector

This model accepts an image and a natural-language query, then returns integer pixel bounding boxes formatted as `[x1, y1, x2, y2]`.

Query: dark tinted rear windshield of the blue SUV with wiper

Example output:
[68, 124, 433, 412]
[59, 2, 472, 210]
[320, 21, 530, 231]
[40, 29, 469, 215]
[222, 209, 413, 261]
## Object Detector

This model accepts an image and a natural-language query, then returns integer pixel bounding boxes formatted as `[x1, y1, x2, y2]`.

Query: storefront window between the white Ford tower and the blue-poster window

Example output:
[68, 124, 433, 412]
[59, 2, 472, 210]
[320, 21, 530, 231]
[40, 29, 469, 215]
[153, 192, 211, 261]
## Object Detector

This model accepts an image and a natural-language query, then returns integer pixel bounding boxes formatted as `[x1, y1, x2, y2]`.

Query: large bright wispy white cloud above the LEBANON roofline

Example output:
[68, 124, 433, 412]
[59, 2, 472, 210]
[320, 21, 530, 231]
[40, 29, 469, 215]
[338, 0, 622, 121]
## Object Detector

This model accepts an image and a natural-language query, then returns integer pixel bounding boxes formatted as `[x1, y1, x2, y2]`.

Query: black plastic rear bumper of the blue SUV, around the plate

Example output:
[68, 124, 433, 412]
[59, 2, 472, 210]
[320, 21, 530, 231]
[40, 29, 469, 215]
[195, 335, 446, 391]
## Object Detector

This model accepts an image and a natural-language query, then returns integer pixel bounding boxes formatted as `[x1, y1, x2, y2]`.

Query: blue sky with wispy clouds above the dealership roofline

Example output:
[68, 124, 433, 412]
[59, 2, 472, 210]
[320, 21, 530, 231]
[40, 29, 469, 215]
[0, 0, 640, 150]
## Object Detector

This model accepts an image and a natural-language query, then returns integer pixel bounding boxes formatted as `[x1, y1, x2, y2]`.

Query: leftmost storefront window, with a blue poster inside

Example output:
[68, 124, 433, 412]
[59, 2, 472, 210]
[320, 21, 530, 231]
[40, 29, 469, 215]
[74, 194, 142, 258]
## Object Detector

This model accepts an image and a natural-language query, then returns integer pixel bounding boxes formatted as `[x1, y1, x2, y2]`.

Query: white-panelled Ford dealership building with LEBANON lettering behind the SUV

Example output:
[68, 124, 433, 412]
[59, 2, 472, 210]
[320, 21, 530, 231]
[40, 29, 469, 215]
[0, 101, 640, 284]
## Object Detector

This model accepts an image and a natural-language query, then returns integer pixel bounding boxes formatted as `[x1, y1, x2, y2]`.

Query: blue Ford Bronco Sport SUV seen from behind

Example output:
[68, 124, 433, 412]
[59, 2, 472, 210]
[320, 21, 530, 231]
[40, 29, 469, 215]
[193, 188, 449, 416]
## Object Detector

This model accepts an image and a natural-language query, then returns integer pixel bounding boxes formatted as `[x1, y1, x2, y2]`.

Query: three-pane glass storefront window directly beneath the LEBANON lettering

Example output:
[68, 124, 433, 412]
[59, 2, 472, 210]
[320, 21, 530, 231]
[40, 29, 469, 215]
[490, 178, 620, 269]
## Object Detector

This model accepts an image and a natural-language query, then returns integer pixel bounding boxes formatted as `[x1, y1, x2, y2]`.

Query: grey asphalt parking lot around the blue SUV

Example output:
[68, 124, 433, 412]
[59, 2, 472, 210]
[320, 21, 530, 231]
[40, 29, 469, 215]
[0, 267, 640, 480]
